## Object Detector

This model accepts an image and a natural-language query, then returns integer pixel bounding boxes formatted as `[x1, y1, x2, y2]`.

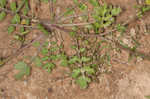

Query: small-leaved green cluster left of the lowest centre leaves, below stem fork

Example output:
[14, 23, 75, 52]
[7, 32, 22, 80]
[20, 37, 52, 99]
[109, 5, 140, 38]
[34, 42, 63, 73]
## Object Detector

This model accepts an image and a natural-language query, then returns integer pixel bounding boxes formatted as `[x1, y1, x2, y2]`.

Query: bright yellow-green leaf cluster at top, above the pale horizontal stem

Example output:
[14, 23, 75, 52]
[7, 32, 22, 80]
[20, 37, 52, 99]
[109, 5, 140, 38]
[59, 0, 122, 33]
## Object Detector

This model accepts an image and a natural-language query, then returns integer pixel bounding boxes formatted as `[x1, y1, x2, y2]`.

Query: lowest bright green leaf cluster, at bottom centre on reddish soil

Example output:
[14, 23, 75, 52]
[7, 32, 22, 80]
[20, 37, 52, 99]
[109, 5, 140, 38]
[67, 51, 96, 88]
